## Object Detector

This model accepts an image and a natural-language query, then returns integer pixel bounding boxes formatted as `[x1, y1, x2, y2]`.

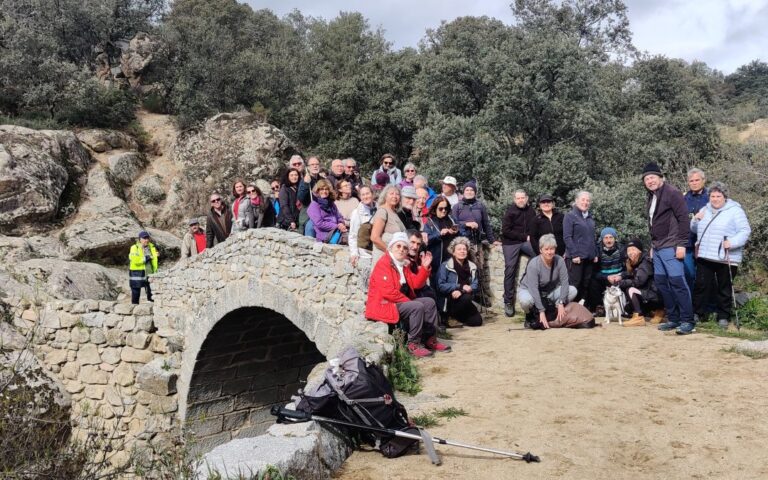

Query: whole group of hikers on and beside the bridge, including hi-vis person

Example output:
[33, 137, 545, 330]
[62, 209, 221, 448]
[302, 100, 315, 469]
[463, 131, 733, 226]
[126, 154, 750, 357]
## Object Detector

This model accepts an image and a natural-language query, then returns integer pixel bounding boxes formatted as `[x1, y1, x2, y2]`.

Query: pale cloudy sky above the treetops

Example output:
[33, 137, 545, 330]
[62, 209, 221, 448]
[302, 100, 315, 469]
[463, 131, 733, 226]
[244, 0, 768, 74]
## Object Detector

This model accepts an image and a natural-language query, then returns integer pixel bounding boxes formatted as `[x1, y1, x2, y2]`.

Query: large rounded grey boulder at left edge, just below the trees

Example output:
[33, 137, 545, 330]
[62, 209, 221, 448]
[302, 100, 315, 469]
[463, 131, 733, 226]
[0, 125, 91, 233]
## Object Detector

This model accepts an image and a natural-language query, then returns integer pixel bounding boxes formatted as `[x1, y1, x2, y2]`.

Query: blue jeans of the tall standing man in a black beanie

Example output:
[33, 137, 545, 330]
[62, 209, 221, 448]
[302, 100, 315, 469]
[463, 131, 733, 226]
[653, 247, 693, 323]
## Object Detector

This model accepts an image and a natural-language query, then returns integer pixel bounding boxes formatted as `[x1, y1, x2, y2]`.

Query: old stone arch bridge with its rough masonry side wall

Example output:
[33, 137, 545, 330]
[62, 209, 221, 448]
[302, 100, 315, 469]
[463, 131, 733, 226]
[16, 228, 388, 464]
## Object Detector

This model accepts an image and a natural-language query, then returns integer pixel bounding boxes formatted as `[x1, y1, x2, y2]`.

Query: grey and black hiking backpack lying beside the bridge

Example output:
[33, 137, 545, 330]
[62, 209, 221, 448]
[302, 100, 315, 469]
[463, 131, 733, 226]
[296, 348, 420, 458]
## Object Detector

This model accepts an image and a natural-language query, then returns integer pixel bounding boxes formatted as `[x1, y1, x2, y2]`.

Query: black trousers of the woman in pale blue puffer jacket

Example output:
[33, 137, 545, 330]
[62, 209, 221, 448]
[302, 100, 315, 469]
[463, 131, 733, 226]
[693, 258, 738, 320]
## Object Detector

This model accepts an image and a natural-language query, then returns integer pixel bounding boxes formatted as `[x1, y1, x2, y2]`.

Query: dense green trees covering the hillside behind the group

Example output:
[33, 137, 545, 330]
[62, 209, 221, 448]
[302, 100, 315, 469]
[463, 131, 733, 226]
[0, 0, 768, 274]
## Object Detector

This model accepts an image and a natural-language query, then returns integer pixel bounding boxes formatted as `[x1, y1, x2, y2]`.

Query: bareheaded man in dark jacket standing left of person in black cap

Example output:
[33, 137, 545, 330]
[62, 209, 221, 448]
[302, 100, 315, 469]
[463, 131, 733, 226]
[501, 190, 536, 317]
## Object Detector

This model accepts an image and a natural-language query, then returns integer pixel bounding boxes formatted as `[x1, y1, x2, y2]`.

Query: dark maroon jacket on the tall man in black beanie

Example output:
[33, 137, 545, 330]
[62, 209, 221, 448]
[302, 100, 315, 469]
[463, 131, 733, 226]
[645, 183, 690, 250]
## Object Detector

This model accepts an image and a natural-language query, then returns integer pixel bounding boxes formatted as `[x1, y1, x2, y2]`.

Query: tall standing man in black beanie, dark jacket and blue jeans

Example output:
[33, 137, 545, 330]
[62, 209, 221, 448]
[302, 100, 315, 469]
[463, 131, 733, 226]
[642, 162, 696, 335]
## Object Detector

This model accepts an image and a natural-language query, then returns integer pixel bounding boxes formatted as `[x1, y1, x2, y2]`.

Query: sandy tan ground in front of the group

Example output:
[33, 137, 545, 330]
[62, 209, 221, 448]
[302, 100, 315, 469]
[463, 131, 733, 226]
[335, 318, 768, 480]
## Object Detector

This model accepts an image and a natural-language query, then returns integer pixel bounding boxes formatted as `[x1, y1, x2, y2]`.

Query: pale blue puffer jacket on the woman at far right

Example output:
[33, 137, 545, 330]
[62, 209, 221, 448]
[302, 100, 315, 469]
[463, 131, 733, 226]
[691, 199, 752, 264]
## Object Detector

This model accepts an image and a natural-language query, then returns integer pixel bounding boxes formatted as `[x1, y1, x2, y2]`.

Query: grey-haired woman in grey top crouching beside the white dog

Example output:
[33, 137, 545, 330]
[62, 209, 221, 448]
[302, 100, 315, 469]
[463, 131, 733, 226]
[517, 233, 577, 329]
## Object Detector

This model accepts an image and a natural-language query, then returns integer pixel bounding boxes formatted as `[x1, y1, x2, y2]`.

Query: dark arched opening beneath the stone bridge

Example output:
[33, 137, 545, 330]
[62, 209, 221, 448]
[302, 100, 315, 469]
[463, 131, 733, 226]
[185, 307, 325, 452]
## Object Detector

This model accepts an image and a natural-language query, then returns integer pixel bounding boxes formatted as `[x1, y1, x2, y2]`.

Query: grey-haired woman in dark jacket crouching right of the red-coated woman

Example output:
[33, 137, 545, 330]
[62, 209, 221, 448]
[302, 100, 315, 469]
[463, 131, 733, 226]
[437, 237, 483, 327]
